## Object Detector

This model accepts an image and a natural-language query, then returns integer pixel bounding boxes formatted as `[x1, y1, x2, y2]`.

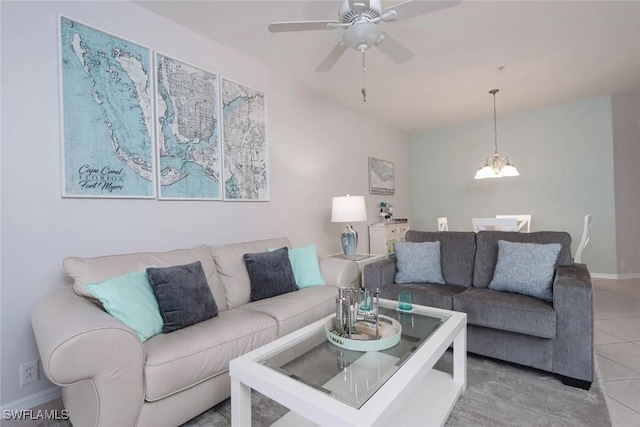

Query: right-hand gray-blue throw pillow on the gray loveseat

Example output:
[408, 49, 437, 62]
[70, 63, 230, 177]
[489, 240, 561, 301]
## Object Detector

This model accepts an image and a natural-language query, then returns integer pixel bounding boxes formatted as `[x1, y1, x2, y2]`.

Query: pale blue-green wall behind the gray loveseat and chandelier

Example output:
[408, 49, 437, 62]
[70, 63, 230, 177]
[411, 96, 616, 274]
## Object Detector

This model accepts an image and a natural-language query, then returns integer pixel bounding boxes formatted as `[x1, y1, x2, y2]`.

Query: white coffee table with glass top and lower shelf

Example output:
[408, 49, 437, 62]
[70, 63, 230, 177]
[229, 299, 467, 427]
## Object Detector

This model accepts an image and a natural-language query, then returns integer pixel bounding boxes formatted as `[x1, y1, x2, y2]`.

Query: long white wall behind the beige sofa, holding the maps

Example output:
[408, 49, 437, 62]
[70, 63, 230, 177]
[0, 1, 411, 406]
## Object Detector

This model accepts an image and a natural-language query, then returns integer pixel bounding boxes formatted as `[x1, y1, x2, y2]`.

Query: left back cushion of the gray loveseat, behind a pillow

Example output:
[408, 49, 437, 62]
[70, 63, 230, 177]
[406, 230, 476, 287]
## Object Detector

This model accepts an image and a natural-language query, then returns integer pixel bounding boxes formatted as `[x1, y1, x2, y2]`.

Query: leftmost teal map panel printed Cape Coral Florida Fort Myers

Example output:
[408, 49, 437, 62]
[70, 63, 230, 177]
[60, 17, 155, 198]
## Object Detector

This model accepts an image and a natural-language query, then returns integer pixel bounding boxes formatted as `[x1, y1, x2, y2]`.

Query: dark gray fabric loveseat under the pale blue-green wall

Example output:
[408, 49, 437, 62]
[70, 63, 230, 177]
[364, 230, 593, 389]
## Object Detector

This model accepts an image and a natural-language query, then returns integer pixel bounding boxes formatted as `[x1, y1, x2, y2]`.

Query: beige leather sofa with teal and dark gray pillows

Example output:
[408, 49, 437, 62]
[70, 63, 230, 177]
[31, 237, 358, 427]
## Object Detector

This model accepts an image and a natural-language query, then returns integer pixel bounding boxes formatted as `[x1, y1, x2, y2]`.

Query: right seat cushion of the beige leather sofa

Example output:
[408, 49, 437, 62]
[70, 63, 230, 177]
[238, 286, 338, 337]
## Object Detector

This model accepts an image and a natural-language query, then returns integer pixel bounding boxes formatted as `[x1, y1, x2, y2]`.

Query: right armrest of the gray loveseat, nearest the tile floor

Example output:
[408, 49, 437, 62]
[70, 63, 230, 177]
[553, 264, 594, 383]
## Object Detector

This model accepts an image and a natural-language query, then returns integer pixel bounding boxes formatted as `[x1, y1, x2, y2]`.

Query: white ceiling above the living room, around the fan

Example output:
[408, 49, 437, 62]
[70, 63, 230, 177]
[138, 0, 640, 133]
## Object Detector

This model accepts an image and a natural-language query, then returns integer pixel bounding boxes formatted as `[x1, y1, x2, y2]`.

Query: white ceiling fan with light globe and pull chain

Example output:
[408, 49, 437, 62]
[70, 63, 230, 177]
[268, 0, 460, 72]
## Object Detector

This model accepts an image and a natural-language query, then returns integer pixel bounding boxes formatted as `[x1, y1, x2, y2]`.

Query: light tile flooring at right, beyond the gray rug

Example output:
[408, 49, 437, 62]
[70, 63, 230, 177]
[593, 279, 640, 427]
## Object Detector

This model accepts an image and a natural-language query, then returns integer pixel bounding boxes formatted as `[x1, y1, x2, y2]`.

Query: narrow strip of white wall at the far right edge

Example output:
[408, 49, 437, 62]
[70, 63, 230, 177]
[611, 93, 640, 277]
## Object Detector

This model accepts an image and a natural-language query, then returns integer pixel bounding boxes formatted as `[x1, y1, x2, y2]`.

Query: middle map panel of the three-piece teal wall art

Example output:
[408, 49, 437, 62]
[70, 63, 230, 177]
[156, 54, 221, 200]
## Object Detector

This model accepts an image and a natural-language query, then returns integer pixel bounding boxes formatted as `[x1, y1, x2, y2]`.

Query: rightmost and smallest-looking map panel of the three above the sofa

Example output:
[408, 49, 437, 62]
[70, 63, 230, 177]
[221, 78, 269, 201]
